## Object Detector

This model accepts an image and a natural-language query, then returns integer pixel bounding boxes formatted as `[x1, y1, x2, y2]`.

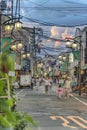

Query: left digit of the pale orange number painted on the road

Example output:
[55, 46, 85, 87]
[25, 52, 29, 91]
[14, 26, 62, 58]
[50, 116, 76, 129]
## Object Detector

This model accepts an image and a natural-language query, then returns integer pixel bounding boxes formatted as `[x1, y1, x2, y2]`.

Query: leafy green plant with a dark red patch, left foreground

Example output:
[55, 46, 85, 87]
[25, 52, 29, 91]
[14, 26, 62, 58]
[0, 53, 37, 130]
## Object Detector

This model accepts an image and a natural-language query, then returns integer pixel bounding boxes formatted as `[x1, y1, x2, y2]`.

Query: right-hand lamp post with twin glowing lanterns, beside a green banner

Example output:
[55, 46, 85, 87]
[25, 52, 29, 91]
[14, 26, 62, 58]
[66, 35, 83, 95]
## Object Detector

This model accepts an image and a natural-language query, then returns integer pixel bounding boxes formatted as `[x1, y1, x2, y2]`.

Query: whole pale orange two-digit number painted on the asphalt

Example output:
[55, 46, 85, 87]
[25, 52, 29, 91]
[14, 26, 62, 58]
[50, 116, 87, 129]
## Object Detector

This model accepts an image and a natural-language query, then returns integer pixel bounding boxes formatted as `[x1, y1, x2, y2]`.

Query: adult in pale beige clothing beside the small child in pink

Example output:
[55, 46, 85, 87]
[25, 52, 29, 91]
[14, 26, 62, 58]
[64, 77, 72, 99]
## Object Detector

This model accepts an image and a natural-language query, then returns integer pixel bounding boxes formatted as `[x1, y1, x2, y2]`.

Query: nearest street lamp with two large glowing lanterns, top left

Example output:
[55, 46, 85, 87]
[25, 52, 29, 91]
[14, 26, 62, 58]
[0, 0, 22, 53]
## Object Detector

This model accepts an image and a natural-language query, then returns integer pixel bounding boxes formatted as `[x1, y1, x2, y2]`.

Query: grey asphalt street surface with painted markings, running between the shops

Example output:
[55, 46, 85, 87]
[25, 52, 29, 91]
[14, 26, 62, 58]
[16, 86, 87, 130]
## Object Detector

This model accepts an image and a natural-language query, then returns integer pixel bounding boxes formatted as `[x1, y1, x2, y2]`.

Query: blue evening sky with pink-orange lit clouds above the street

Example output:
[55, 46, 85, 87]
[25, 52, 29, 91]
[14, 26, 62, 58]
[21, 0, 87, 48]
